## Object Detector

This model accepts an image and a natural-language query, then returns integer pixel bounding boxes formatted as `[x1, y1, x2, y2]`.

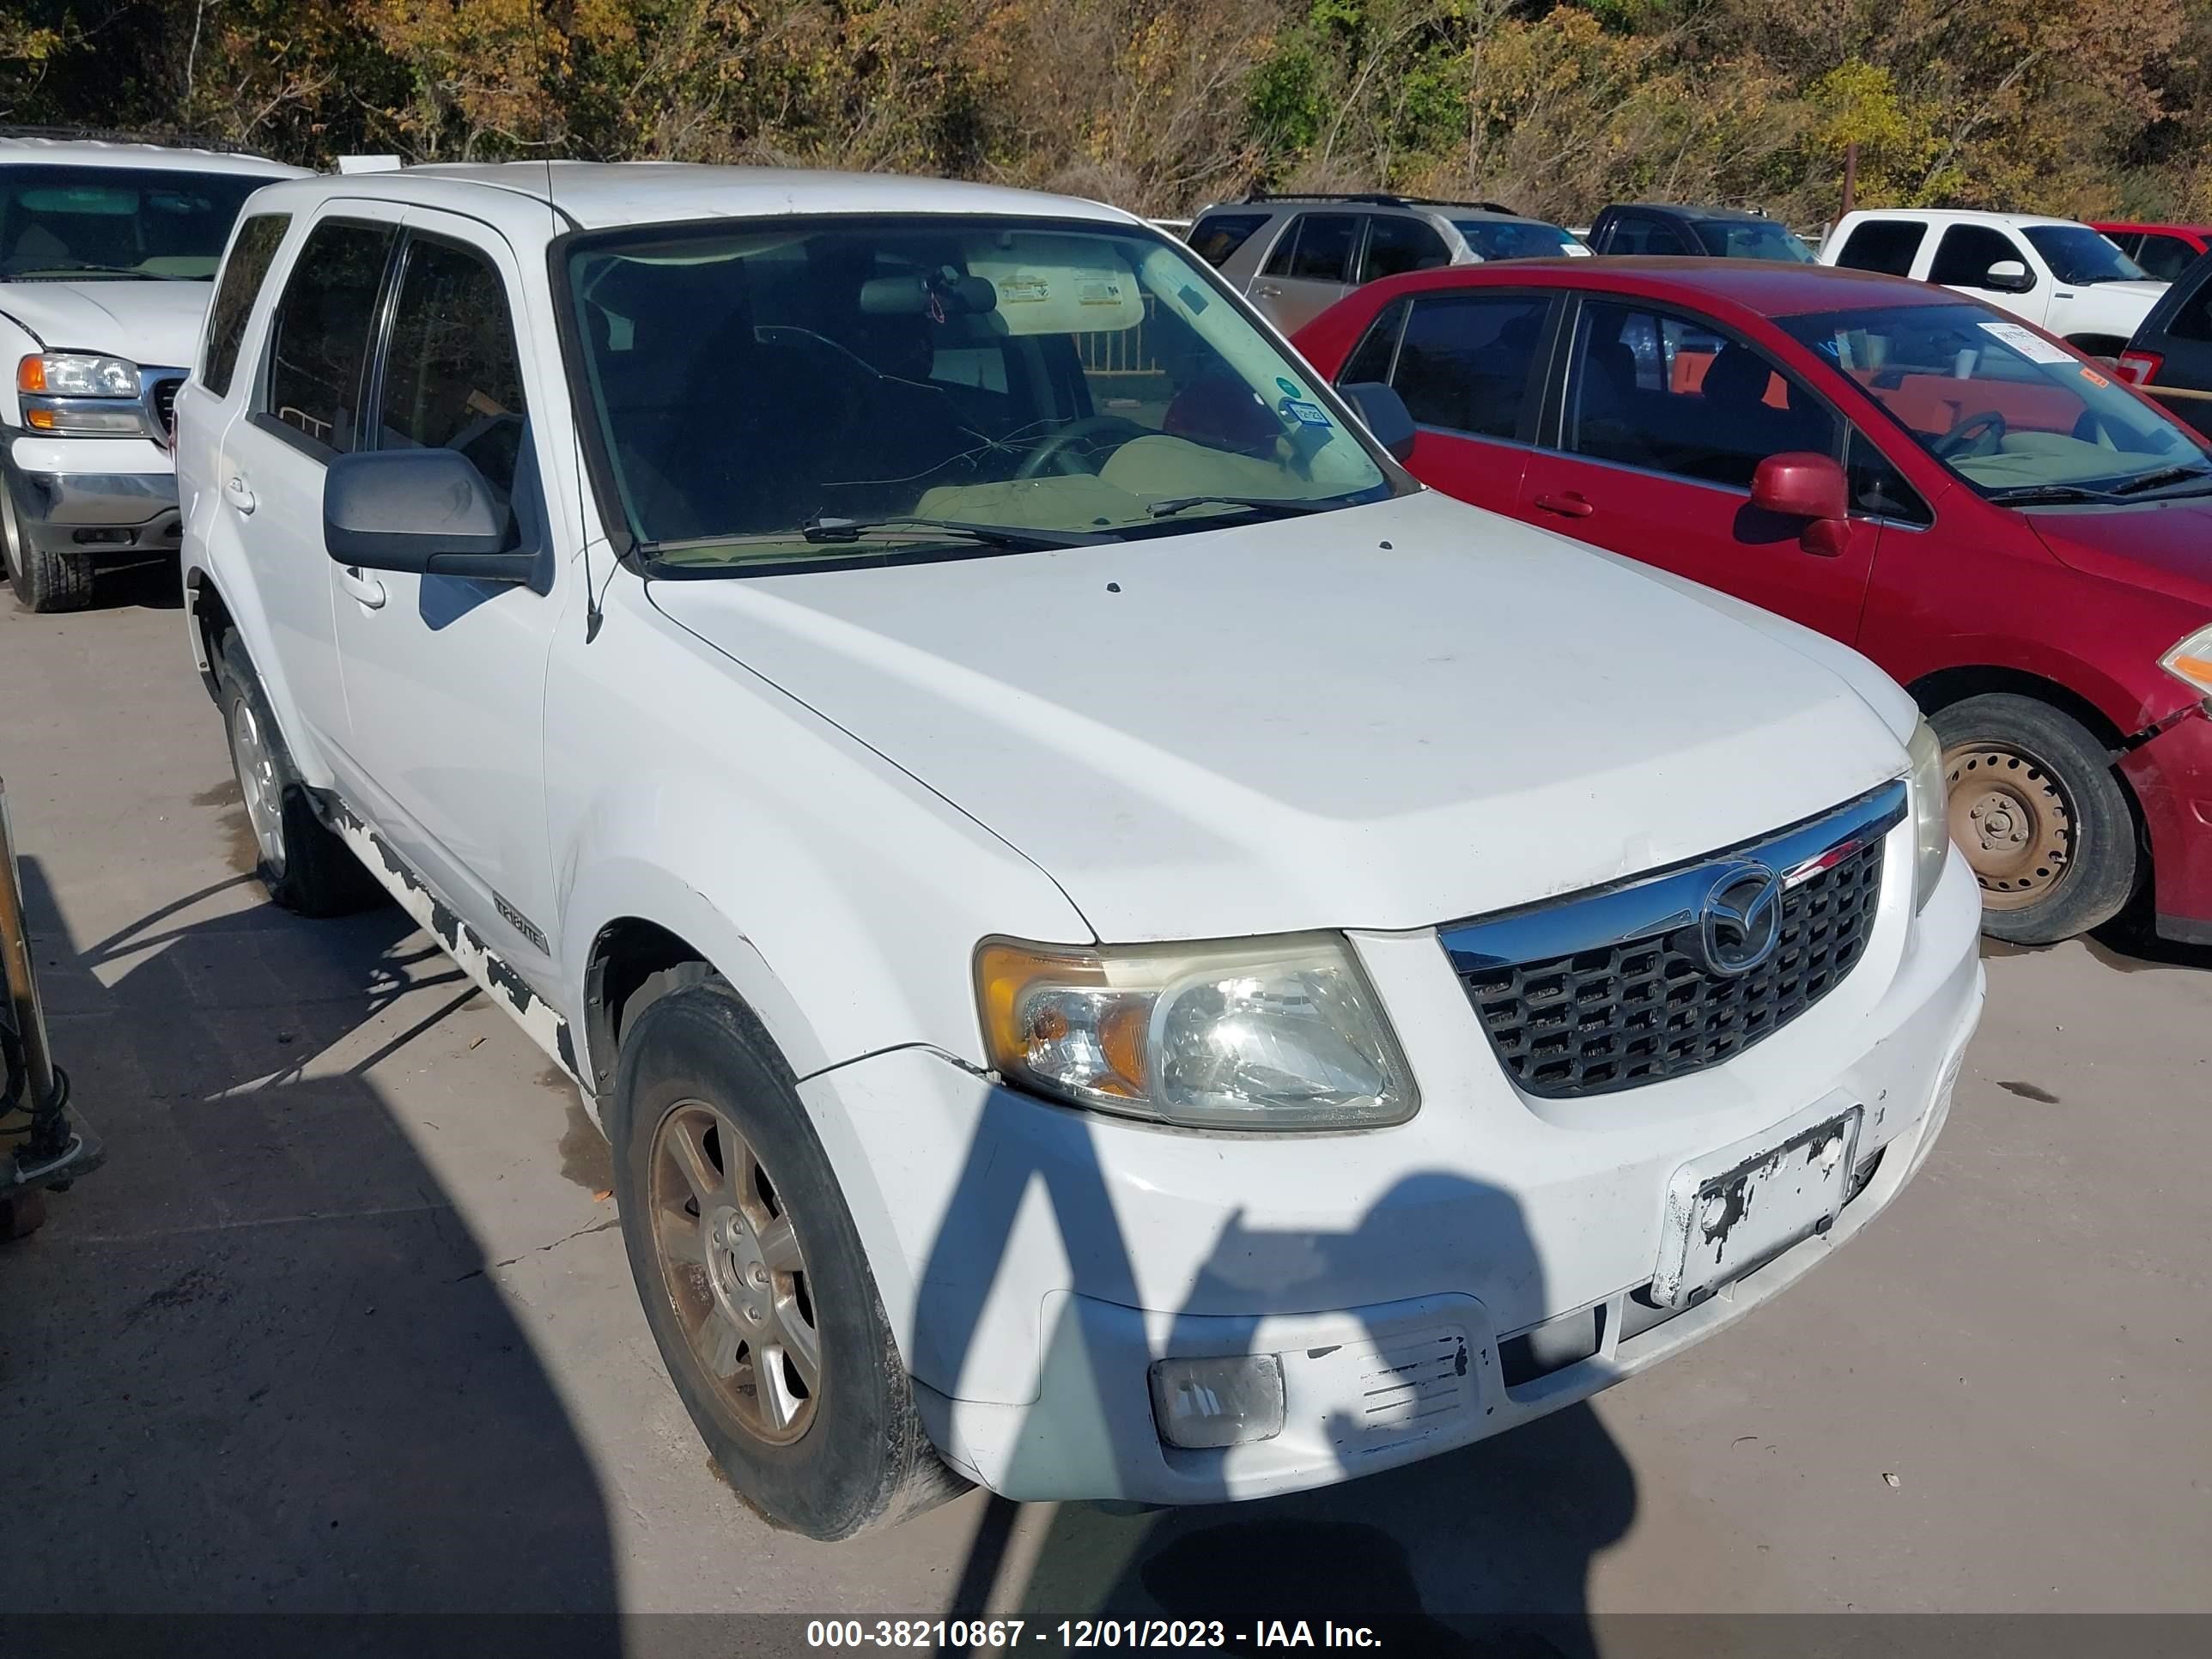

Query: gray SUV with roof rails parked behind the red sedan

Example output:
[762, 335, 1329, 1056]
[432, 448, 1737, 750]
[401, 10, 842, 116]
[1188, 195, 1590, 334]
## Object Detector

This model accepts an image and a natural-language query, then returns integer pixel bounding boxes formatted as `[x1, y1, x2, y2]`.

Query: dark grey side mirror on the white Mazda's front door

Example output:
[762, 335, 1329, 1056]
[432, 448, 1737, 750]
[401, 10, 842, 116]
[323, 449, 538, 581]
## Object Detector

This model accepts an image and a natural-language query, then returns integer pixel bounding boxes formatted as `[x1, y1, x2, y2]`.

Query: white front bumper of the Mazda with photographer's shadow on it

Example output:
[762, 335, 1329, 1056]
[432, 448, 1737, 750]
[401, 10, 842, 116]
[801, 823, 1982, 1504]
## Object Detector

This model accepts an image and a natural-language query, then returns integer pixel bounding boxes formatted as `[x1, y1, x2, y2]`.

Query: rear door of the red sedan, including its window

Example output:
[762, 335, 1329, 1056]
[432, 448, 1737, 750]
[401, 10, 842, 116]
[1336, 288, 1558, 514]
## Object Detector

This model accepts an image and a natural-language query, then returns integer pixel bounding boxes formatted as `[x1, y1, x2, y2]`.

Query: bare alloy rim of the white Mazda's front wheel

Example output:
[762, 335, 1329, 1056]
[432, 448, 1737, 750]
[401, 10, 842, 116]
[646, 1099, 823, 1444]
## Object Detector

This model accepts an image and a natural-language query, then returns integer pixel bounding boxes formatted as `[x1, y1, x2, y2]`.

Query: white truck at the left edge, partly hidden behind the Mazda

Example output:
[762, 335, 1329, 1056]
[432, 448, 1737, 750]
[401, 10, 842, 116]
[0, 137, 301, 611]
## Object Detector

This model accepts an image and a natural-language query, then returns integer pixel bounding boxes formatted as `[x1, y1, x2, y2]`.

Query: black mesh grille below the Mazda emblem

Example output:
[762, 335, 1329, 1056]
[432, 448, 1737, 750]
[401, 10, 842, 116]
[1453, 834, 1882, 1099]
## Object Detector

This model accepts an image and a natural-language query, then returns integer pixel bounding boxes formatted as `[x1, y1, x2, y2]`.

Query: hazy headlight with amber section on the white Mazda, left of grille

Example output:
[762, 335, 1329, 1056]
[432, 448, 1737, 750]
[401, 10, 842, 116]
[975, 933, 1420, 1130]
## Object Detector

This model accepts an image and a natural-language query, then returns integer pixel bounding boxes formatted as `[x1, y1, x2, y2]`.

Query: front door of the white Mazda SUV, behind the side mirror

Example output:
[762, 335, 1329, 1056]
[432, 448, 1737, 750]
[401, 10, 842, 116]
[325, 210, 566, 994]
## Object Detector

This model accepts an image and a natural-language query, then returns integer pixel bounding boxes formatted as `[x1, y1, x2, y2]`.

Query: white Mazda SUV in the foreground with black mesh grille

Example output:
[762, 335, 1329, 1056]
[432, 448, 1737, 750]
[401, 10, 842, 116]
[179, 166, 1982, 1537]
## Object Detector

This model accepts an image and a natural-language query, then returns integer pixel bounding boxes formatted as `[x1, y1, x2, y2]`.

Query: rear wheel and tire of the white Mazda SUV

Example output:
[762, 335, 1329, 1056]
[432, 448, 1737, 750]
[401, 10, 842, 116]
[215, 633, 385, 915]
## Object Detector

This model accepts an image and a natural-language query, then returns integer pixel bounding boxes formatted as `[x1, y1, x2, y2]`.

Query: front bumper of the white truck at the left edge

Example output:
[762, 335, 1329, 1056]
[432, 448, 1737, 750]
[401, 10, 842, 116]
[0, 435, 184, 560]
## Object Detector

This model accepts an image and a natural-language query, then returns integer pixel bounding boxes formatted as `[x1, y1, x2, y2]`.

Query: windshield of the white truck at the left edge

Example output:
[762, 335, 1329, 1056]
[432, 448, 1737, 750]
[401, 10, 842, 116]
[0, 166, 270, 283]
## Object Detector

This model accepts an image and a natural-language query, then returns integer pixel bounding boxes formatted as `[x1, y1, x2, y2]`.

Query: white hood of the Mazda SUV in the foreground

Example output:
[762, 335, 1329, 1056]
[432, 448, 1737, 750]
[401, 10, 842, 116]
[650, 493, 1909, 942]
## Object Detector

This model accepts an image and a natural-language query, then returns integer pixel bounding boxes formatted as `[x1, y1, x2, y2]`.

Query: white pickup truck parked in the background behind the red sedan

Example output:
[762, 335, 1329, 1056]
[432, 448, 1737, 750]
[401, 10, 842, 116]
[1820, 208, 2166, 358]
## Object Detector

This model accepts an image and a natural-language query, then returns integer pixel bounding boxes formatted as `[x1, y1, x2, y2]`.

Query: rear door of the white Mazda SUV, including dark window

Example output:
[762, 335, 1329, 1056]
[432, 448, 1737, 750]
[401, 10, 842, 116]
[212, 201, 398, 782]
